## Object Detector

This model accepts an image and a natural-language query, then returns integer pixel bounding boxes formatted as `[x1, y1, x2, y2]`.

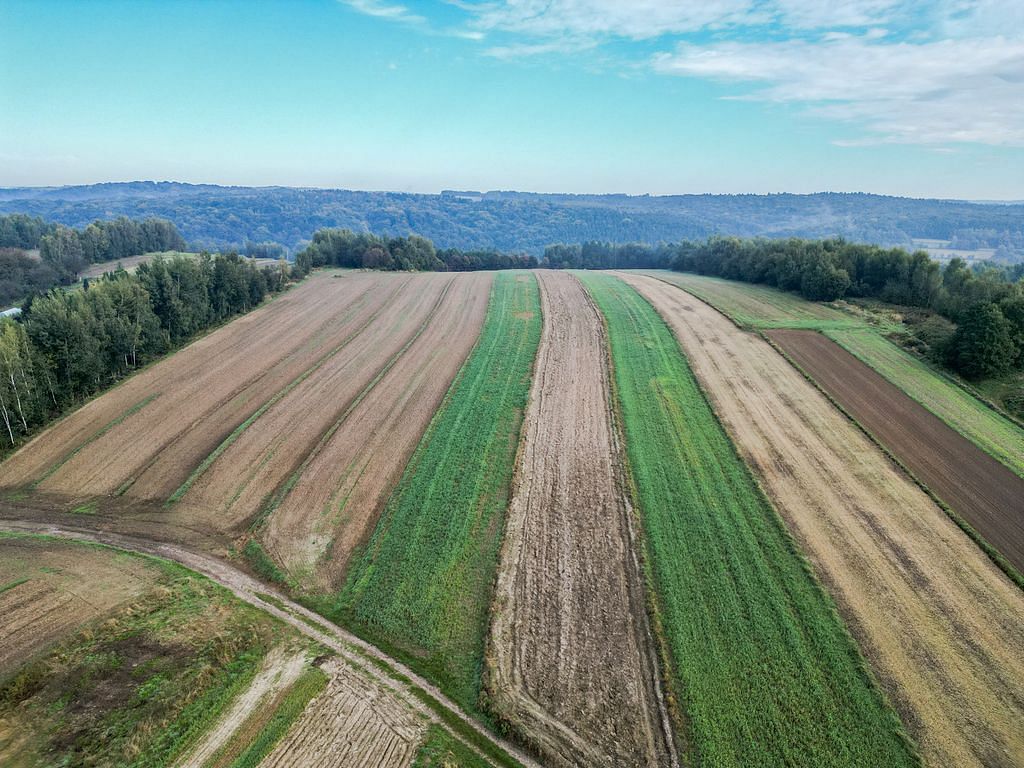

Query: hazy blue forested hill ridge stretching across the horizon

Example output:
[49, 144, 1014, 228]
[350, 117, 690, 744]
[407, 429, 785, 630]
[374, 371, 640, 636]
[0, 181, 1024, 258]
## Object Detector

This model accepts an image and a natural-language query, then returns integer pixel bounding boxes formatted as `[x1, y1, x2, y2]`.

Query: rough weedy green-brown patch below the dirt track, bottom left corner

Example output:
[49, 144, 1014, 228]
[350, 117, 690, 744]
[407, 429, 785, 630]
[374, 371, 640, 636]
[0, 560, 290, 768]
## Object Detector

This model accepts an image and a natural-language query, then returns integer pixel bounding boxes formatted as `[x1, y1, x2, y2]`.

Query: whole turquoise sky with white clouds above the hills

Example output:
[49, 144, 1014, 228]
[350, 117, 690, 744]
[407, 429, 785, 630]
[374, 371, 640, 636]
[0, 0, 1024, 200]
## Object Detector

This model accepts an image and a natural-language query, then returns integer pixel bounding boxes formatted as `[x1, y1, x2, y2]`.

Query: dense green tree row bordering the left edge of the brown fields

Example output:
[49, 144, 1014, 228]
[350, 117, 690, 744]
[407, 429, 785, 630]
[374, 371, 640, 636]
[0, 253, 293, 446]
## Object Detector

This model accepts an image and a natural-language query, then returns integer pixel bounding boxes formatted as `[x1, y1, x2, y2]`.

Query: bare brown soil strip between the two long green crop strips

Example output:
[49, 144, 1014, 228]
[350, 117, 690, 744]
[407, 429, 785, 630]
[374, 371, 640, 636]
[487, 271, 674, 766]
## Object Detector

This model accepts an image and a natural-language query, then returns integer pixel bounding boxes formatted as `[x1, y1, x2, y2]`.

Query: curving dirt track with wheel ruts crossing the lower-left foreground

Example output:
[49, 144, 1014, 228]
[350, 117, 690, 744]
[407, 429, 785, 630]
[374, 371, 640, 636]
[0, 517, 542, 768]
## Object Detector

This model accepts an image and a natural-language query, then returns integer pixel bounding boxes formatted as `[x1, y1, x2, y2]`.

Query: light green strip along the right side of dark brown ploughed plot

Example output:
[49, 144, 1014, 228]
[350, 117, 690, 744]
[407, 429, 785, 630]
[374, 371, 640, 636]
[825, 329, 1024, 477]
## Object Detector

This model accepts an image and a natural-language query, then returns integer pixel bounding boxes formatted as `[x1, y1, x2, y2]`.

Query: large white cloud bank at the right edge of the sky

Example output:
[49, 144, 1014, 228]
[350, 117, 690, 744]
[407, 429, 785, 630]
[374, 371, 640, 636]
[653, 37, 1024, 146]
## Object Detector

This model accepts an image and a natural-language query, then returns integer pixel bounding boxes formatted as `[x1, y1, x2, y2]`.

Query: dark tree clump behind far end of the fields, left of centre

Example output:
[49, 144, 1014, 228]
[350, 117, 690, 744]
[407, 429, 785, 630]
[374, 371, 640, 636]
[295, 227, 538, 274]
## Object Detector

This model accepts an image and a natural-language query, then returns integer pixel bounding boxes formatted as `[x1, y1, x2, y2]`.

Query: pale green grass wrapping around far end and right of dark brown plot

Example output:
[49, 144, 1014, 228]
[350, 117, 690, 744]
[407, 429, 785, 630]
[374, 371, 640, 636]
[645, 270, 1024, 477]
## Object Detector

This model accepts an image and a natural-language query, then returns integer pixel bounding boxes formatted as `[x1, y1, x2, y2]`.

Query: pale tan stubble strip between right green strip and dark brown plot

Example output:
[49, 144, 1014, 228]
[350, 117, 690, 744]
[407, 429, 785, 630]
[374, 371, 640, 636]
[621, 274, 1024, 766]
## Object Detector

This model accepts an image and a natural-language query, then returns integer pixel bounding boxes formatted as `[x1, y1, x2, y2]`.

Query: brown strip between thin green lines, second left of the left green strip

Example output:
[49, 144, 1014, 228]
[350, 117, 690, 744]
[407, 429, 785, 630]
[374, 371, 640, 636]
[180, 273, 455, 529]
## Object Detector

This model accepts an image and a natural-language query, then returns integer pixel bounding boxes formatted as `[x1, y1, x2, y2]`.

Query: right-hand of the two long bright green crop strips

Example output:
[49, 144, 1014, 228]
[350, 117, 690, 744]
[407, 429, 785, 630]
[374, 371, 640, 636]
[581, 273, 915, 766]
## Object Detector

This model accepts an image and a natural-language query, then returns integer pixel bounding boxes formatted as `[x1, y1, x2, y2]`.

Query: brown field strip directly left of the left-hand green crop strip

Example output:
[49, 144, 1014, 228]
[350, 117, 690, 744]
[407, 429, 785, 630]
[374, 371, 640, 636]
[264, 273, 494, 589]
